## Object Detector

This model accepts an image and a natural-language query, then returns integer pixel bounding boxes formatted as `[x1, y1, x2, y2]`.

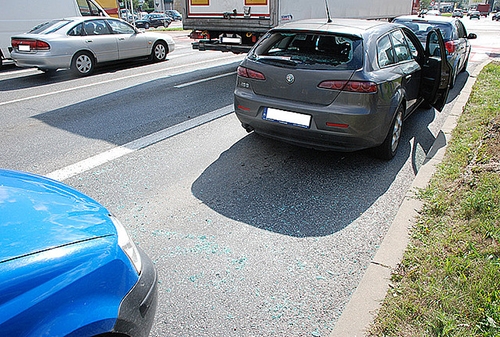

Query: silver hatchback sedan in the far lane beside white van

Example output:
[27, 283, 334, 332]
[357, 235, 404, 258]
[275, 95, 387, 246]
[11, 17, 175, 76]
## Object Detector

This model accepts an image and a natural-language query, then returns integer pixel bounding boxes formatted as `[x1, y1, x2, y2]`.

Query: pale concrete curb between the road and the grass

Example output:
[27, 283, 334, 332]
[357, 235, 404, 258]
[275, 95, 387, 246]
[330, 59, 491, 337]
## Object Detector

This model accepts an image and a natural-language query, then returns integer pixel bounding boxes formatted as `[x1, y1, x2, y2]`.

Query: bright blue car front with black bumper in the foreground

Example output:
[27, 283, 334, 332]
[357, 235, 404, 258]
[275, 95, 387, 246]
[0, 170, 158, 337]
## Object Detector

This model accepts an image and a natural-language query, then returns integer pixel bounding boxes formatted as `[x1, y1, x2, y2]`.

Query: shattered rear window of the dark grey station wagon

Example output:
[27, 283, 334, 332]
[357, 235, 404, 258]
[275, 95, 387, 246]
[248, 31, 363, 70]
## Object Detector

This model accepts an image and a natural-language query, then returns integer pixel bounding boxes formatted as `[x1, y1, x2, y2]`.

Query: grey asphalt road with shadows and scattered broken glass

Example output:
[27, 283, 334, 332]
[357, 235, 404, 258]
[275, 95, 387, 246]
[0, 16, 500, 336]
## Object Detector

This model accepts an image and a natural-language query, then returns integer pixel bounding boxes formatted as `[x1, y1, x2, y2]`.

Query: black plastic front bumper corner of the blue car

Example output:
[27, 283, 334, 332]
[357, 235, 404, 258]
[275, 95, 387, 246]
[113, 247, 158, 337]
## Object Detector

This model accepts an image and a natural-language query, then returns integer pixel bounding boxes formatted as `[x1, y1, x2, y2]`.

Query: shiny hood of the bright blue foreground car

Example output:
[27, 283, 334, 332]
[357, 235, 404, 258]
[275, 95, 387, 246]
[0, 170, 116, 263]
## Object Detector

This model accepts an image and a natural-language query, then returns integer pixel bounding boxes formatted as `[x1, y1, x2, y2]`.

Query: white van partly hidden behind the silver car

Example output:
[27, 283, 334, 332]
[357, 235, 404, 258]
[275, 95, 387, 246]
[0, 0, 108, 67]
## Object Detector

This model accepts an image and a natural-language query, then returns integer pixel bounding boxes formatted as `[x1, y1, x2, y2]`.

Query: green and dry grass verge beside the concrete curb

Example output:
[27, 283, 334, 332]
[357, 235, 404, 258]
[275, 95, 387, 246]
[369, 62, 500, 337]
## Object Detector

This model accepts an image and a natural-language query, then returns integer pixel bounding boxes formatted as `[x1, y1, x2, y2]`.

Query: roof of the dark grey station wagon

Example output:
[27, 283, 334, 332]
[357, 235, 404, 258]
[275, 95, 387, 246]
[273, 18, 395, 37]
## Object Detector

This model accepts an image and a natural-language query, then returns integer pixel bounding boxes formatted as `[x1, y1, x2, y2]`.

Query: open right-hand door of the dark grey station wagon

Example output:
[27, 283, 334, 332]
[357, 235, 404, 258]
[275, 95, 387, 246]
[420, 29, 453, 111]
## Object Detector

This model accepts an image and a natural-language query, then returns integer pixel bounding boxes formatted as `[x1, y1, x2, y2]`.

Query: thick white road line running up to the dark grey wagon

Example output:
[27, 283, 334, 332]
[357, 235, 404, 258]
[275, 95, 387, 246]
[46, 105, 233, 181]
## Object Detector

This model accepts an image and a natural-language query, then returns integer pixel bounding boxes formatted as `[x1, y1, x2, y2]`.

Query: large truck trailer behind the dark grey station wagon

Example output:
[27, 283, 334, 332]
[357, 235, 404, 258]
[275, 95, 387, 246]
[182, 0, 413, 53]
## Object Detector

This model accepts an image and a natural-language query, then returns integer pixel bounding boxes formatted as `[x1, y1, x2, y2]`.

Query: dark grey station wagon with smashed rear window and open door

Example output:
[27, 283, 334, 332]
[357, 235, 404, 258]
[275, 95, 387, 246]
[234, 19, 451, 159]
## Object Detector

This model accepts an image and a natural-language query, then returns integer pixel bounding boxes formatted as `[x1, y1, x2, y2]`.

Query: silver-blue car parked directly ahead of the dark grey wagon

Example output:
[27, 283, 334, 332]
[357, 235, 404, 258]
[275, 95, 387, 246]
[393, 15, 477, 87]
